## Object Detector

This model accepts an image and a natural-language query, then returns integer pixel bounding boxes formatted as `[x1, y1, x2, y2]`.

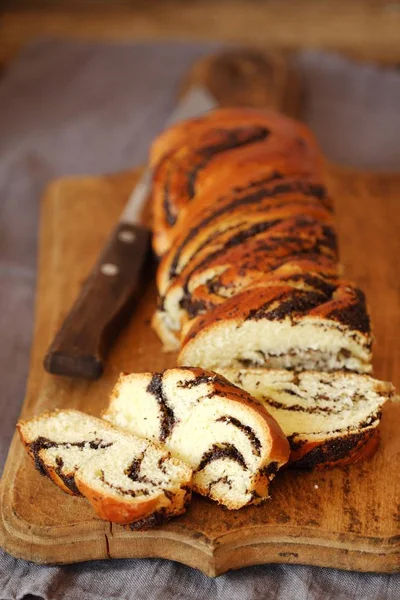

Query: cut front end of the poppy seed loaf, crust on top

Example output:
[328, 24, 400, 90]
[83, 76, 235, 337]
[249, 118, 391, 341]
[178, 273, 372, 373]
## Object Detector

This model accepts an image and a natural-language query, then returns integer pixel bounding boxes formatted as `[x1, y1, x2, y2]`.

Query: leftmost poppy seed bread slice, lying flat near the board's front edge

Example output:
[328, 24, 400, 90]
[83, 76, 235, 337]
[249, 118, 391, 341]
[17, 410, 192, 527]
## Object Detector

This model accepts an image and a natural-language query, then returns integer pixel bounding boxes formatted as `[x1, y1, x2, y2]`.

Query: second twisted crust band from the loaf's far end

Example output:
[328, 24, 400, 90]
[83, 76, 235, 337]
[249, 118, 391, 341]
[158, 169, 332, 284]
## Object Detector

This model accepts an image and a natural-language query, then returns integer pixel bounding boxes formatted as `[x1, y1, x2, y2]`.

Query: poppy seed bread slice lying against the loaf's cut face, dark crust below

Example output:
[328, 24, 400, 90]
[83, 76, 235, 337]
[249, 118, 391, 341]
[217, 369, 394, 469]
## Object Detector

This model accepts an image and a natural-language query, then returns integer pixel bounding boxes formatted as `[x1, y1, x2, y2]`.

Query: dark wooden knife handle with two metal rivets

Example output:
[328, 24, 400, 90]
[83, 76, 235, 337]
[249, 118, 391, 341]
[44, 223, 151, 379]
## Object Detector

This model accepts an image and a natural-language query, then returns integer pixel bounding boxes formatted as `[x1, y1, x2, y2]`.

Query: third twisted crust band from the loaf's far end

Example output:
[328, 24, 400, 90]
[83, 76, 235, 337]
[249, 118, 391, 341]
[158, 209, 337, 296]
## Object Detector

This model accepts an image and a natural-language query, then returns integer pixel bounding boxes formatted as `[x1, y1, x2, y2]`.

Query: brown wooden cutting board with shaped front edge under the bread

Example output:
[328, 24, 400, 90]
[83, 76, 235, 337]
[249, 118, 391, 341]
[0, 162, 400, 576]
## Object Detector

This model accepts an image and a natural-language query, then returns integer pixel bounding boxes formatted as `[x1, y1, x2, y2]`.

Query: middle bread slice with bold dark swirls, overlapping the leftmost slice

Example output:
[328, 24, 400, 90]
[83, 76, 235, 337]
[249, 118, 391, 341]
[103, 368, 289, 509]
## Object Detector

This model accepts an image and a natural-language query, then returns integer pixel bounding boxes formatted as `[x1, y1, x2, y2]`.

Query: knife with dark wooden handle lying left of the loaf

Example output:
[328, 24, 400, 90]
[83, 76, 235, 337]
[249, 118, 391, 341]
[44, 86, 218, 380]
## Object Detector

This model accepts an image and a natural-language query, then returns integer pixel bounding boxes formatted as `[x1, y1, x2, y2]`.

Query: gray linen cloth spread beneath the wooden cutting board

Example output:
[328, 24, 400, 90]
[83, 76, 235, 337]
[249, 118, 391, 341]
[0, 40, 400, 600]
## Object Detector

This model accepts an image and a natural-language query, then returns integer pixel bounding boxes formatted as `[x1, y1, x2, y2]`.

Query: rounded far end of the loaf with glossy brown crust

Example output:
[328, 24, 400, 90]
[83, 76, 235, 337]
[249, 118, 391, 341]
[151, 109, 323, 255]
